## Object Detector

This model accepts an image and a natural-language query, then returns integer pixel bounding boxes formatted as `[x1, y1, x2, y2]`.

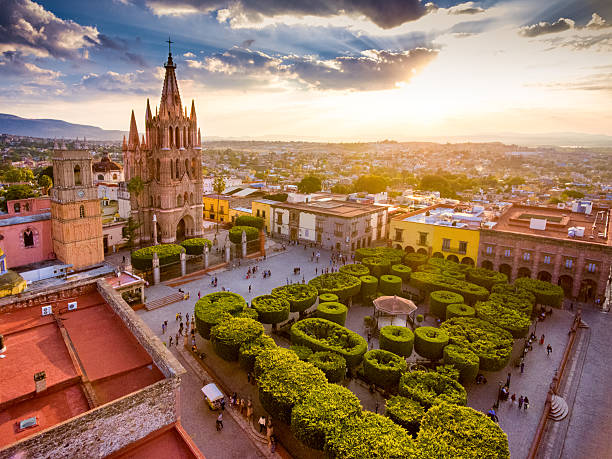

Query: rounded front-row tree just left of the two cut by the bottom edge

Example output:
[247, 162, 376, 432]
[291, 384, 361, 450]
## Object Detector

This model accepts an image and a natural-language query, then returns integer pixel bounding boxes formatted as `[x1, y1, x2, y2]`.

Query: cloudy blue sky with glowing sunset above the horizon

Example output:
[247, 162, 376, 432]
[0, 0, 612, 141]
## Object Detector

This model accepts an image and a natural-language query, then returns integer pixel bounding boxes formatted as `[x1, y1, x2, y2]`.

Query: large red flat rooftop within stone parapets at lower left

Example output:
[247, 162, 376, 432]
[0, 292, 164, 448]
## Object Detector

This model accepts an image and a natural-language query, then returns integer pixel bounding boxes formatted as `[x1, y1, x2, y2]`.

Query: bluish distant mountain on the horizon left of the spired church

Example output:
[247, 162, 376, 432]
[0, 113, 127, 140]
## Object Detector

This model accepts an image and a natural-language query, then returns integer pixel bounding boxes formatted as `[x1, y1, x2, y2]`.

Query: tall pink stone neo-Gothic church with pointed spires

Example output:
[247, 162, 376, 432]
[123, 45, 203, 244]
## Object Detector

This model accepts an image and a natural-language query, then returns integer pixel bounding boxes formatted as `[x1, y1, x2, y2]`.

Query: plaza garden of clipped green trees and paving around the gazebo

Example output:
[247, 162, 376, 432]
[131, 234, 573, 457]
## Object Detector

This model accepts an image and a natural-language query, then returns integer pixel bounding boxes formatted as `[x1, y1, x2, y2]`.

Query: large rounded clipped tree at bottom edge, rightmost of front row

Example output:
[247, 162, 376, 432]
[417, 403, 510, 459]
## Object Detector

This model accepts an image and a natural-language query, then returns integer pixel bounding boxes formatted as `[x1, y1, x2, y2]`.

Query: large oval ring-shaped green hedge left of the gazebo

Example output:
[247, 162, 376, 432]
[291, 319, 368, 367]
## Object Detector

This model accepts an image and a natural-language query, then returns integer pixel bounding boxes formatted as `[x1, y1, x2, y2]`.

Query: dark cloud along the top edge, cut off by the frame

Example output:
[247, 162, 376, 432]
[147, 0, 428, 29]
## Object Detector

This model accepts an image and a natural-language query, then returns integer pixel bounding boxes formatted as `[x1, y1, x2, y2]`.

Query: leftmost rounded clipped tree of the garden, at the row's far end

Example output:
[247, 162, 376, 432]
[194, 292, 246, 339]
